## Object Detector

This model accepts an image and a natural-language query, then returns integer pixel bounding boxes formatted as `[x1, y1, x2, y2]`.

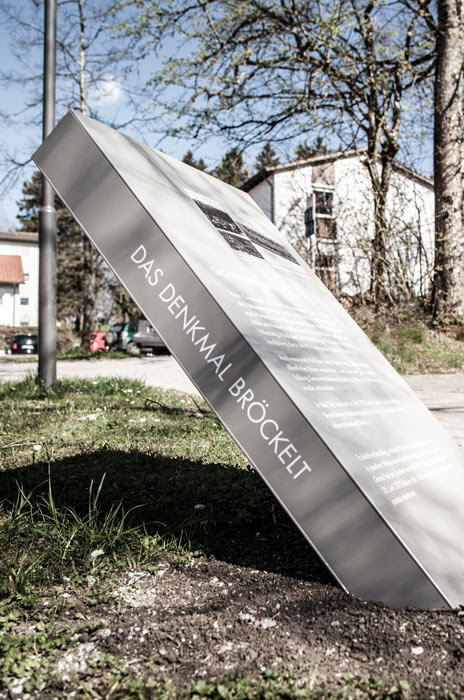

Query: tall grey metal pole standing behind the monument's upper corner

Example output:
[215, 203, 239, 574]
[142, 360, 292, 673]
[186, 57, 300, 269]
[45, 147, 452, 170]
[39, 0, 56, 389]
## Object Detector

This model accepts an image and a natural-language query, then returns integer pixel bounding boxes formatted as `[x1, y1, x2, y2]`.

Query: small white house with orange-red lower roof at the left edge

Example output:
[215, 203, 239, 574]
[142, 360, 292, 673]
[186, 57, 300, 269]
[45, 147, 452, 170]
[0, 231, 39, 326]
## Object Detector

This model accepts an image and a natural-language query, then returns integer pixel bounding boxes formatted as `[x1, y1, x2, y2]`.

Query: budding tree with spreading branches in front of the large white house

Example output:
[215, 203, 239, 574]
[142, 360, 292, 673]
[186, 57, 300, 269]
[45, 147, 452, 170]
[115, 0, 434, 303]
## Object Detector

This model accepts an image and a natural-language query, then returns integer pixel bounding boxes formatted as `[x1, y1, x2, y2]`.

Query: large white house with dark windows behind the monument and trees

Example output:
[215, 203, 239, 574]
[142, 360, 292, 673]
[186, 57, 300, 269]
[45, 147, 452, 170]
[243, 149, 434, 296]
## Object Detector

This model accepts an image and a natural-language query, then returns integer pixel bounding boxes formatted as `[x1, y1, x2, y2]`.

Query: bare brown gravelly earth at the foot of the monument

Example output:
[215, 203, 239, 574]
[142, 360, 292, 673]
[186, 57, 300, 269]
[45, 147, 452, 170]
[34, 559, 464, 698]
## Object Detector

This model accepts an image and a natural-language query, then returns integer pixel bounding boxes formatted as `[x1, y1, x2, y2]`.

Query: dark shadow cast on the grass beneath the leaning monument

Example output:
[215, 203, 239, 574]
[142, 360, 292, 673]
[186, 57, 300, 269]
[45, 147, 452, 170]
[0, 450, 334, 583]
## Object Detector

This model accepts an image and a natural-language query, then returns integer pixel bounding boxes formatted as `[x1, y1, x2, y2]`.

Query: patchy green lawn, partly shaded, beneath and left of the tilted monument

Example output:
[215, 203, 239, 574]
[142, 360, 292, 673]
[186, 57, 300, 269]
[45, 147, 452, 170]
[0, 379, 460, 700]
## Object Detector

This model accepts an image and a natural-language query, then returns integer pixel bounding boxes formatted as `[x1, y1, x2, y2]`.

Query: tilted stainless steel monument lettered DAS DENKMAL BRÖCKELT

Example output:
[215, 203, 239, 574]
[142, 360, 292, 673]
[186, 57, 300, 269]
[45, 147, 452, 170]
[34, 112, 464, 607]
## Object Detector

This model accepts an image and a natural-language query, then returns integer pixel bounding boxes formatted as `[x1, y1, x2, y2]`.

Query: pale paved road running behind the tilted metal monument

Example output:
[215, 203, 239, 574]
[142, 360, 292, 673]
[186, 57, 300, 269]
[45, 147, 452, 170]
[0, 355, 464, 447]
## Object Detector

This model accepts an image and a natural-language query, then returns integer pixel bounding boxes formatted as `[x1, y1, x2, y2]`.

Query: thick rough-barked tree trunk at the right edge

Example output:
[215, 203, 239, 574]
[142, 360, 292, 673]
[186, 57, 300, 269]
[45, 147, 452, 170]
[432, 0, 464, 321]
